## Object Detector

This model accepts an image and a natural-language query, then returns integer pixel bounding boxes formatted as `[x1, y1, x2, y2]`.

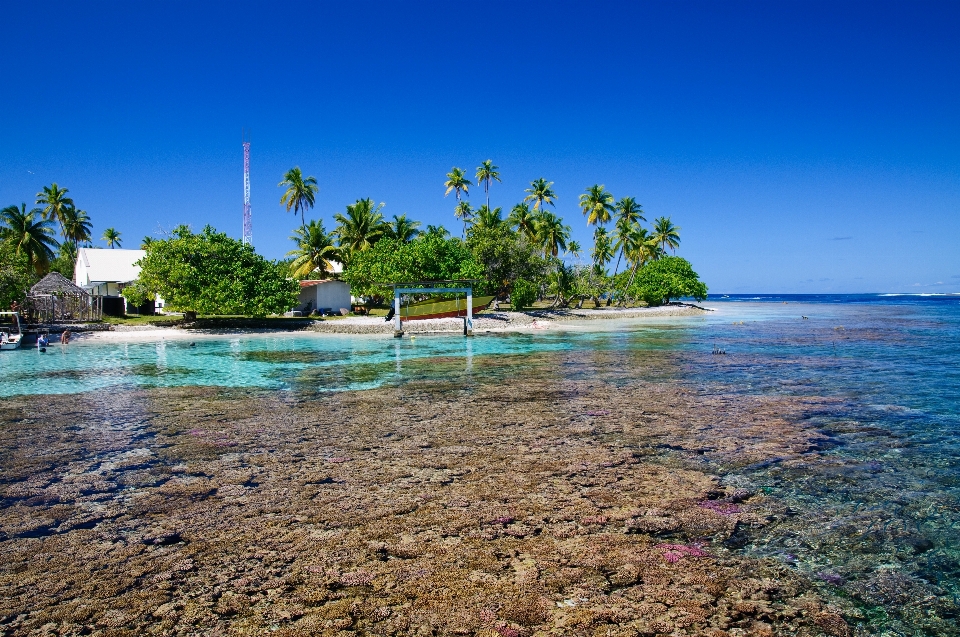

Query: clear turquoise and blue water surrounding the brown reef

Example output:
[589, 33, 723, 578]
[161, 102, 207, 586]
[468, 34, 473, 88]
[0, 295, 960, 635]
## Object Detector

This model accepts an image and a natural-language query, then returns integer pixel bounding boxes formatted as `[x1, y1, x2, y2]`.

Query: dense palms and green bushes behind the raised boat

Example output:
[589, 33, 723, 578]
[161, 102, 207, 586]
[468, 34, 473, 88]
[280, 159, 707, 307]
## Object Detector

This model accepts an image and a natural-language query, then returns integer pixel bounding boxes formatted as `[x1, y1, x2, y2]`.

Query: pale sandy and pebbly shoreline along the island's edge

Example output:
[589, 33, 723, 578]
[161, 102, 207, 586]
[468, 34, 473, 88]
[73, 304, 712, 342]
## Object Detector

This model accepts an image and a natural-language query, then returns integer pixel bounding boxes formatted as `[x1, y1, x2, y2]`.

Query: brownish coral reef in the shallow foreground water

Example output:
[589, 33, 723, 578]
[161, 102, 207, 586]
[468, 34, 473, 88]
[0, 355, 852, 637]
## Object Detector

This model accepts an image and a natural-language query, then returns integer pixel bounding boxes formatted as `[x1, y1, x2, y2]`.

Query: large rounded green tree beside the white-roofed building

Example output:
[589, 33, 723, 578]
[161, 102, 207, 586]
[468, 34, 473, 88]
[124, 226, 300, 318]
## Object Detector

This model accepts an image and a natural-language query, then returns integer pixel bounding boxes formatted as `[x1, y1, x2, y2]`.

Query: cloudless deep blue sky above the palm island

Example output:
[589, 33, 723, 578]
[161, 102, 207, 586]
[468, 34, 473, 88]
[0, 1, 960, 293]
